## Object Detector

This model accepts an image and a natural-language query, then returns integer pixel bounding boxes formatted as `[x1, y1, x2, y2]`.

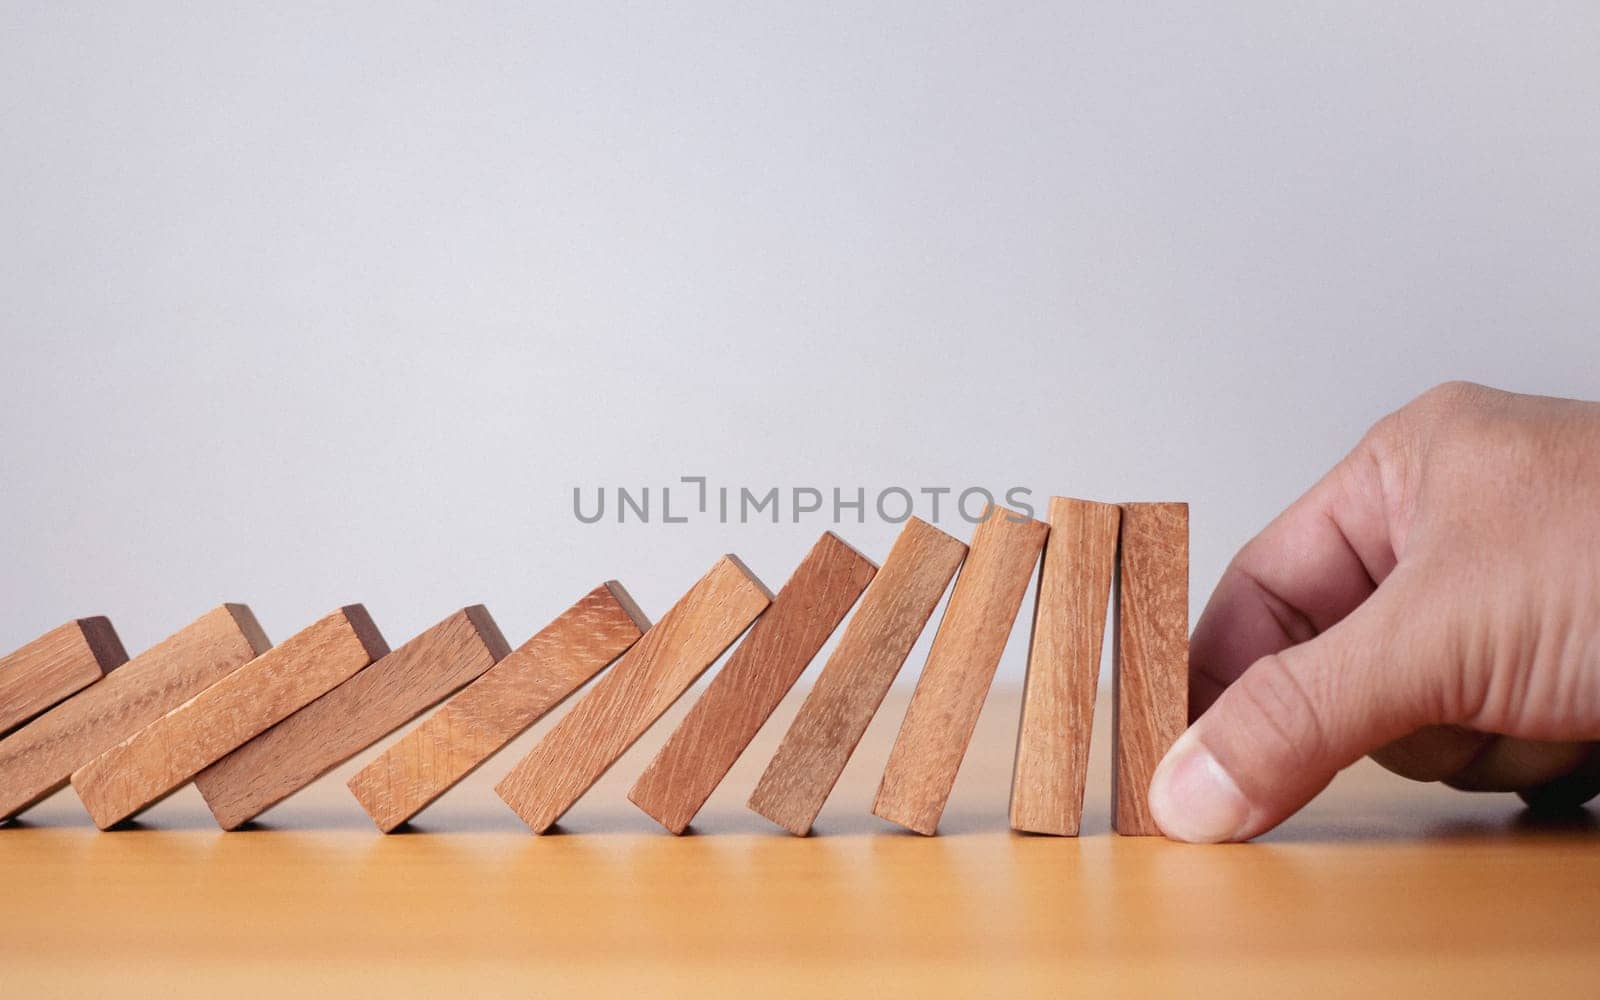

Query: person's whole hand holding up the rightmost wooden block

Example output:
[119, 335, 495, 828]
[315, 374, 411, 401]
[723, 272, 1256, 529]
[1150, 382, 1600, 843]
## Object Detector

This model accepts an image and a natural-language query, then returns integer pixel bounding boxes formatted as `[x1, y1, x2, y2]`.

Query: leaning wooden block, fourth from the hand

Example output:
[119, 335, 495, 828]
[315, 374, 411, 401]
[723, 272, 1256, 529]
[749, 517, 966, 837]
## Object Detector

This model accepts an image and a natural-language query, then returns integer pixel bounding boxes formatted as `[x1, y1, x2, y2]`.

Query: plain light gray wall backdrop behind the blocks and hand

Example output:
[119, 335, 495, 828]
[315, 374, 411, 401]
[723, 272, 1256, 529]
[0, 2, 1600, 677]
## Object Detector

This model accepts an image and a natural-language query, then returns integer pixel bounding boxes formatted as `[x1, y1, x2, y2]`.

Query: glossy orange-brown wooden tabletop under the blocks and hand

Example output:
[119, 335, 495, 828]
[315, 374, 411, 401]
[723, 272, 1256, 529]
[0, 688, 1600, 1000]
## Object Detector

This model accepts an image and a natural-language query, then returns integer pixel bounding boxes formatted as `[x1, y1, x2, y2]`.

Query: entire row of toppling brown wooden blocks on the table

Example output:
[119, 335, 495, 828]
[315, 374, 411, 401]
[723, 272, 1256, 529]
[0, 498, 1189, 835]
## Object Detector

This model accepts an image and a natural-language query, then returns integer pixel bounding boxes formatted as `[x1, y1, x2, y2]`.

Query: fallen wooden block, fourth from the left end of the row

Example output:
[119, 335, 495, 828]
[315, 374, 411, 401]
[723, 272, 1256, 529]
[195, 605, 510, 830]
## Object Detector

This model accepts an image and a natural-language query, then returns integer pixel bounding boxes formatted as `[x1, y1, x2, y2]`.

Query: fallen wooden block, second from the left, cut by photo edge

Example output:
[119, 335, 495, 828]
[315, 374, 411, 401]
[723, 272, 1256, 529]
[0, 605, 272, 819]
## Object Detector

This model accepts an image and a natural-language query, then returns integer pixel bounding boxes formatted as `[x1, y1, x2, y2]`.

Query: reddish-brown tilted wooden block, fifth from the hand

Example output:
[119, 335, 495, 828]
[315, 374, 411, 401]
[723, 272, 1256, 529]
[627, 531, 878, 834]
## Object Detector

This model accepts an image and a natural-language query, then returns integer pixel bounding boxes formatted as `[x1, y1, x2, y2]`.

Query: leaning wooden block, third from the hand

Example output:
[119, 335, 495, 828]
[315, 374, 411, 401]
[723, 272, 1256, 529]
[872, 506, 1050, 837]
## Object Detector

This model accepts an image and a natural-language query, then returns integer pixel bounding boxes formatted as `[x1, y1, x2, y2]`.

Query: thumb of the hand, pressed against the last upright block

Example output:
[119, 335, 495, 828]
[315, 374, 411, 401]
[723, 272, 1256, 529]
[1150, 578, 1440, 843]
